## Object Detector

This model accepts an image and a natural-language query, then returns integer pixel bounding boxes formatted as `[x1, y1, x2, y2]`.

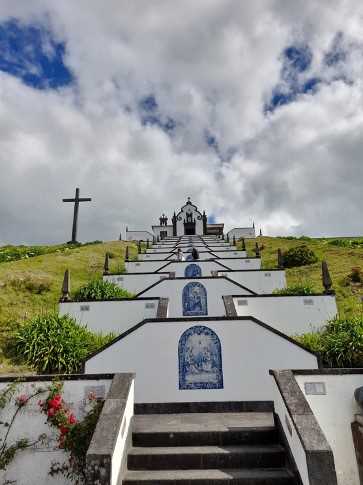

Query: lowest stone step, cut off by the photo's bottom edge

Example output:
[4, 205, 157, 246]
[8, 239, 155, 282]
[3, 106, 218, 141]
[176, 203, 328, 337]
[122, 468, 296, 485]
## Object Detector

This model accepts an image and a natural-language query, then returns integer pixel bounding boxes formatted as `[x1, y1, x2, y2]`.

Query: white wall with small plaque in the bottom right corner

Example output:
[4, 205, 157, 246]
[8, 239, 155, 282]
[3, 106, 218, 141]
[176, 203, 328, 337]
[295, 371, 363, 485]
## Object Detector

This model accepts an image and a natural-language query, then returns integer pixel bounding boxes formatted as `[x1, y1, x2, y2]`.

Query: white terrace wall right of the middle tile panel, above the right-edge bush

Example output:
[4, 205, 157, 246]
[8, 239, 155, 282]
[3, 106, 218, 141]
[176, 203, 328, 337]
[233, 295, 337, 335]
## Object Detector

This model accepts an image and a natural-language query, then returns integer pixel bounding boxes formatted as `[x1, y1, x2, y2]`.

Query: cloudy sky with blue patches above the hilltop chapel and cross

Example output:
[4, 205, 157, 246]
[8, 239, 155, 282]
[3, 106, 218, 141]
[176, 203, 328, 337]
[0, 0, 363, 244]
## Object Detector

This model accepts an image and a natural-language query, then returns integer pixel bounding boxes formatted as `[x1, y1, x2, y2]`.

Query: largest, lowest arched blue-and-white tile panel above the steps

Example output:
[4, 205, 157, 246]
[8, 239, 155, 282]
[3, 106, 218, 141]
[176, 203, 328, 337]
[178, 325, 223, 389]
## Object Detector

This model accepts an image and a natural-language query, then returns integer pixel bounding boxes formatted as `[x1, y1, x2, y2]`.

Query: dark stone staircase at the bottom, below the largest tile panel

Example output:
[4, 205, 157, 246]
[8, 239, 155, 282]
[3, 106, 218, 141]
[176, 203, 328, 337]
[122, 405, 298, 485]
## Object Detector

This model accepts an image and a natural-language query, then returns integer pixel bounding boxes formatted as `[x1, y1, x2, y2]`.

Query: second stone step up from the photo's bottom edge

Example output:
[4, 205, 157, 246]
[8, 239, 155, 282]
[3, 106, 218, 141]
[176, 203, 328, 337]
[128, 444, 285, 470]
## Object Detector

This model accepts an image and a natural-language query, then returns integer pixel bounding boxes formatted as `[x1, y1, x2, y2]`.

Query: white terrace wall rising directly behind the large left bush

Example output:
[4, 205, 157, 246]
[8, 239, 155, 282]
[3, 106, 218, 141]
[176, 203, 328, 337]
[59, 298, 159, 335]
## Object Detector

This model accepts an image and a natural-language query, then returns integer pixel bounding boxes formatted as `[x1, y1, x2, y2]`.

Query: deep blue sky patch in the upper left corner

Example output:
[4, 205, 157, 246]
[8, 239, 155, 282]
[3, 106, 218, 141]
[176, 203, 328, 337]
[0, 19, 73, 89]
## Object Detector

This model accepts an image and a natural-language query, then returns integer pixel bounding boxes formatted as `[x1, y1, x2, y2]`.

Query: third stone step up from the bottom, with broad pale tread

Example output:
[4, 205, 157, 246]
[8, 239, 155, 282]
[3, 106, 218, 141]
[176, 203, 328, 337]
[133, 412, 277, 447]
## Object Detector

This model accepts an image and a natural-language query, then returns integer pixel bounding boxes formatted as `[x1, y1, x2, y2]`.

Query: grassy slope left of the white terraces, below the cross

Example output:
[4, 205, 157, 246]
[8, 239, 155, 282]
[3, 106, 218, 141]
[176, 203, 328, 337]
[0, 241, 137, 373]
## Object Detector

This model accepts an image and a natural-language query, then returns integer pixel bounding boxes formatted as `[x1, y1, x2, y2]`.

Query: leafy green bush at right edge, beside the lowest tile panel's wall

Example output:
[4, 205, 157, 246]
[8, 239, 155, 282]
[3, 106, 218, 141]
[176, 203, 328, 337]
[296, 316, 363, 367]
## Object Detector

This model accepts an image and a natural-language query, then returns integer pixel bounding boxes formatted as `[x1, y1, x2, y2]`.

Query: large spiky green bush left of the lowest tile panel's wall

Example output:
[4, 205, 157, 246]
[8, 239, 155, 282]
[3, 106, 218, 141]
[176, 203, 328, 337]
[14, 313, 114, 374]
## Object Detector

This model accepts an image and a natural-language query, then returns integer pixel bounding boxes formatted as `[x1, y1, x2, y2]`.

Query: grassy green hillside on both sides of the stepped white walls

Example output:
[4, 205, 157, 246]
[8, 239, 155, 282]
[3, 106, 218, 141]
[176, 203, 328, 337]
[0, 237, 363, 373]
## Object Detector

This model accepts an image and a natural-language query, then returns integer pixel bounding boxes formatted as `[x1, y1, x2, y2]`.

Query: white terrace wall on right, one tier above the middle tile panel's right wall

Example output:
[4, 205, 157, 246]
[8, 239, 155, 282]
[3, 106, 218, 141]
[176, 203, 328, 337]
[218, 268, 286, 294]
